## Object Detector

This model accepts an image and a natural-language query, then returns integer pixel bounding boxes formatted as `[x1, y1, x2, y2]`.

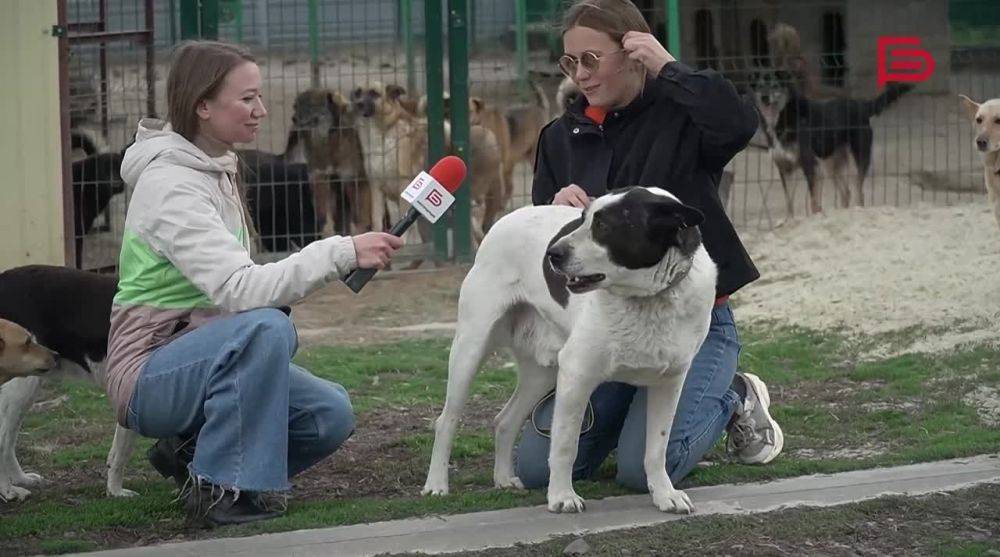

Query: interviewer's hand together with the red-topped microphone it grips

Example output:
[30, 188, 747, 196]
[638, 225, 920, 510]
[344, 155, 466, 294]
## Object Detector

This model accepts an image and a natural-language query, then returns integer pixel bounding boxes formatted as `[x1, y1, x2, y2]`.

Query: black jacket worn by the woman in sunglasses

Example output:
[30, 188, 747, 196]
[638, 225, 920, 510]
[531, 62, 760, 296]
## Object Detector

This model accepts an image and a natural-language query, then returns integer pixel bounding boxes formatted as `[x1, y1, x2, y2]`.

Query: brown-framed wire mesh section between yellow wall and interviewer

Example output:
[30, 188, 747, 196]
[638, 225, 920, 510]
[64, 0, 156, 269]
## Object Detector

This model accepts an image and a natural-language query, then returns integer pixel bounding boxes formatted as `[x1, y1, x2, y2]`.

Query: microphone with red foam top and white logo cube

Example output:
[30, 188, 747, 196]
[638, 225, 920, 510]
[344, 155, 466, 294]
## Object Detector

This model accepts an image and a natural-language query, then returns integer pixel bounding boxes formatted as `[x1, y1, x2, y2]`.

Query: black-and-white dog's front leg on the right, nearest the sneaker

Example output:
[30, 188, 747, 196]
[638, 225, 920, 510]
[643, 373, 694, 514]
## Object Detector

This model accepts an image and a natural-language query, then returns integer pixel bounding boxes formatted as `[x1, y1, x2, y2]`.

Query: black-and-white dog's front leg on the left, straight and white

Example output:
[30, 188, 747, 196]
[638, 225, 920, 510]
[548, 358, 605, 513]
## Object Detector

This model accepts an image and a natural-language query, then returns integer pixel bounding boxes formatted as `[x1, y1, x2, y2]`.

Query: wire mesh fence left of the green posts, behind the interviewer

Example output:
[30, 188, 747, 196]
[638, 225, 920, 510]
[65, 0, 440, 268]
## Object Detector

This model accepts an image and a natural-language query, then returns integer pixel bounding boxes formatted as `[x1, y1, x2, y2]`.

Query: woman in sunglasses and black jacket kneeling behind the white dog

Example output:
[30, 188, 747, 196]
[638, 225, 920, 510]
[517, 0, 783, 491]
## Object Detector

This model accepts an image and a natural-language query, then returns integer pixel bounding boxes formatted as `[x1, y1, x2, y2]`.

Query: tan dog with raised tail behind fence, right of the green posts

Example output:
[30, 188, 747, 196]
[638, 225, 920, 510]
[469, 83, 549, 205]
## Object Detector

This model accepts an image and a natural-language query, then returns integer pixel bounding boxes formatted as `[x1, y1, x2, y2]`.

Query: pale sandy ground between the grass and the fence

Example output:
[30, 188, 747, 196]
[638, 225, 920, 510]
[294, 203, 1000, 357]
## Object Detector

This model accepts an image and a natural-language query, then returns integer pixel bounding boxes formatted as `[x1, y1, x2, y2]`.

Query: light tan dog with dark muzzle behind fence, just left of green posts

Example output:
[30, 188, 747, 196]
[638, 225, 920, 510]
[350, 83, 427, 243]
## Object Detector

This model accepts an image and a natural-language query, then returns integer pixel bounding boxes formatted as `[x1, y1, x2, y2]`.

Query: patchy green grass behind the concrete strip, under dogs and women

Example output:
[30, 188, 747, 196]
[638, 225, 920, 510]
[0, 328, 1000, 554]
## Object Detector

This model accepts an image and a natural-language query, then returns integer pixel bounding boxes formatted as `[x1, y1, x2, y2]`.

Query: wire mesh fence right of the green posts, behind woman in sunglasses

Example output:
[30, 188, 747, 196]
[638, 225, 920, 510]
[470, 0, 1000, 235]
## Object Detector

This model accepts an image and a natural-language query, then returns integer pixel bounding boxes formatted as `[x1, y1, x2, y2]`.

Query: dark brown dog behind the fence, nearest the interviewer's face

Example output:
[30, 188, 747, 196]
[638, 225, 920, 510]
[285, 89, 372, 236]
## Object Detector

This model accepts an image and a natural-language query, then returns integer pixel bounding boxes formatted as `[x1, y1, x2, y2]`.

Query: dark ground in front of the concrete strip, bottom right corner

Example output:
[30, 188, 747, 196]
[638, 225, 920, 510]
[436, 484, 1000, 557]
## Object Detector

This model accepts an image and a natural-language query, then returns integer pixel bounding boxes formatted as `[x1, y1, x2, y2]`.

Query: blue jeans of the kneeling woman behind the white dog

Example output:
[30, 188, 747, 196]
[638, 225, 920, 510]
[516, 304, 741, 491]
